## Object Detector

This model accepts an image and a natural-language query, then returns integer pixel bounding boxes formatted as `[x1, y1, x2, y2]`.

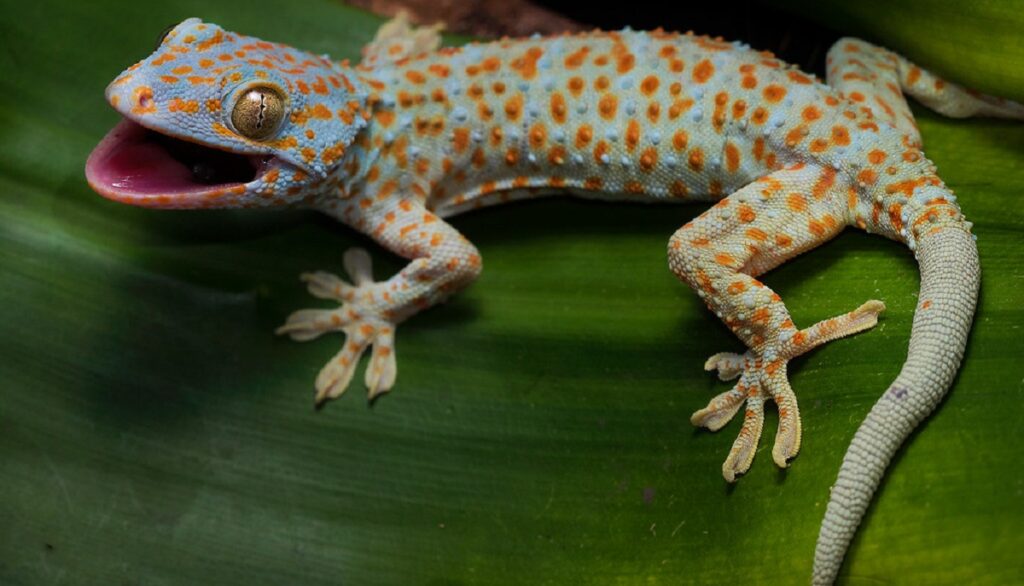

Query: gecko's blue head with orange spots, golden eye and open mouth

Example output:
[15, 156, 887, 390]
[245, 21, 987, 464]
[85, 18, 368, 208]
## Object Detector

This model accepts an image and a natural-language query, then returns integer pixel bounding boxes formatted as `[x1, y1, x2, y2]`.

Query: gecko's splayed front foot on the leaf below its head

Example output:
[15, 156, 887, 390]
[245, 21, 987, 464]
[274, 248, 397, 407]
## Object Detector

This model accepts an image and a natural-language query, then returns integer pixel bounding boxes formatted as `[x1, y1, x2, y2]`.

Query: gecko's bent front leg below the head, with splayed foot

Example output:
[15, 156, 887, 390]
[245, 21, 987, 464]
[276, 199, 481, 407]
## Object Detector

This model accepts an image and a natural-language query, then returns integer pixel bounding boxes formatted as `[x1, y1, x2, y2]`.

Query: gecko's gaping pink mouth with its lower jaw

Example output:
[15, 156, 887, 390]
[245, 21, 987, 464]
[85, 119, 274, 207]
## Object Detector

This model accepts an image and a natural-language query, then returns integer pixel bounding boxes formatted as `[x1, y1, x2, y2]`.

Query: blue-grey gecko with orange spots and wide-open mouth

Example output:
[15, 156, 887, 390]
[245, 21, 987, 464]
[86, 12, 1024, 584]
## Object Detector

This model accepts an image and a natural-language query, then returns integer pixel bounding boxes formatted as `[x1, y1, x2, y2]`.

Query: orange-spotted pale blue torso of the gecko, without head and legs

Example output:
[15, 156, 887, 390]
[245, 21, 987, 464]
[339, 26, 940, 242]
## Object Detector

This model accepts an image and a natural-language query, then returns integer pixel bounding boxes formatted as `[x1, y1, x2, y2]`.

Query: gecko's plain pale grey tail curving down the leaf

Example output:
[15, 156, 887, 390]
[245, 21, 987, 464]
[812, 224, 981, 585]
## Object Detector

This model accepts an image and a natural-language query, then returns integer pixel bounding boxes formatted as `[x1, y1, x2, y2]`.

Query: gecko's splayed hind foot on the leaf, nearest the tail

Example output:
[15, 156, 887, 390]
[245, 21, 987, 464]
[690, 300, 886, 483]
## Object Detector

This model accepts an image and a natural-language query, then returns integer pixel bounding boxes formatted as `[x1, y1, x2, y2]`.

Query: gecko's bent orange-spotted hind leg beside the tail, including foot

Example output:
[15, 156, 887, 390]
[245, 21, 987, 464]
[669, 165, 885, 483]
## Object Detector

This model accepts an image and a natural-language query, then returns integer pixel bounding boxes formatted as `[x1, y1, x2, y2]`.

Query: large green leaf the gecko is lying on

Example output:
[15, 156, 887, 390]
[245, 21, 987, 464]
[0, 0, 1024, 585]
